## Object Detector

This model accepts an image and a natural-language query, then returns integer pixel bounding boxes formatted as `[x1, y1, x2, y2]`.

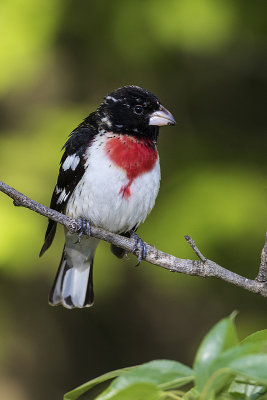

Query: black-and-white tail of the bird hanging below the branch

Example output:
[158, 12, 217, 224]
[49, 238, 99, 309]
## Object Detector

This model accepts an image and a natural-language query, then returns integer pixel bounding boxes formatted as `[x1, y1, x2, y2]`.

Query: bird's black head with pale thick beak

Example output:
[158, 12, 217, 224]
[97, 86, 175, 139]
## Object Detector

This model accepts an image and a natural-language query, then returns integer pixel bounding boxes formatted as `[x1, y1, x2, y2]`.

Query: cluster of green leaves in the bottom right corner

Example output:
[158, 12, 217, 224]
[64, 314, 267, 400]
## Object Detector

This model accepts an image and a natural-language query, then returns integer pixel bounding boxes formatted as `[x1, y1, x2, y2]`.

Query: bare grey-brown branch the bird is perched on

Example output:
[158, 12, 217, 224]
[0, 181, 267, 297]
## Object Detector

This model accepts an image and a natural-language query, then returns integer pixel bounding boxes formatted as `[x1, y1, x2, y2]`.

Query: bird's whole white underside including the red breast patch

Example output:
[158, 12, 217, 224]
[67, 135, 160, 232]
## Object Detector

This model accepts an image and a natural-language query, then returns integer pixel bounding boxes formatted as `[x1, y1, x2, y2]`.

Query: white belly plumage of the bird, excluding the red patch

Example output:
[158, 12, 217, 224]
[66, 137, 160, 233]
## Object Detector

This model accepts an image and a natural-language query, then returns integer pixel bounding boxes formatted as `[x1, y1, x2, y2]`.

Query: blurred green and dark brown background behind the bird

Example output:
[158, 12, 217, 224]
[0, 0, 267, 400]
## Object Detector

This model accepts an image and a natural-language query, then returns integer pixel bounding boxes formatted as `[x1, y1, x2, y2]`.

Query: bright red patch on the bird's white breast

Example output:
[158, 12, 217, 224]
[105, 135, 158, 197]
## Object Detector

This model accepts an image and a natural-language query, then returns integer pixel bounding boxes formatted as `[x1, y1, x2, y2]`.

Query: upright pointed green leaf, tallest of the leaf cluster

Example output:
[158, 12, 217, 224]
[194, 314, 238, 391]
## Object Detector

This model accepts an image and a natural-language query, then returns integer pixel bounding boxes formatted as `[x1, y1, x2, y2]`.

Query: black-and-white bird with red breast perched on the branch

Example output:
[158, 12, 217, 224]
[40, 85, 176, 309]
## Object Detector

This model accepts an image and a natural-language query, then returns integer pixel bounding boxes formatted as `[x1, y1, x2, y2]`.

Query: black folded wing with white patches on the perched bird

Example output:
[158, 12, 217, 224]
[39, 118, 97, 257]
